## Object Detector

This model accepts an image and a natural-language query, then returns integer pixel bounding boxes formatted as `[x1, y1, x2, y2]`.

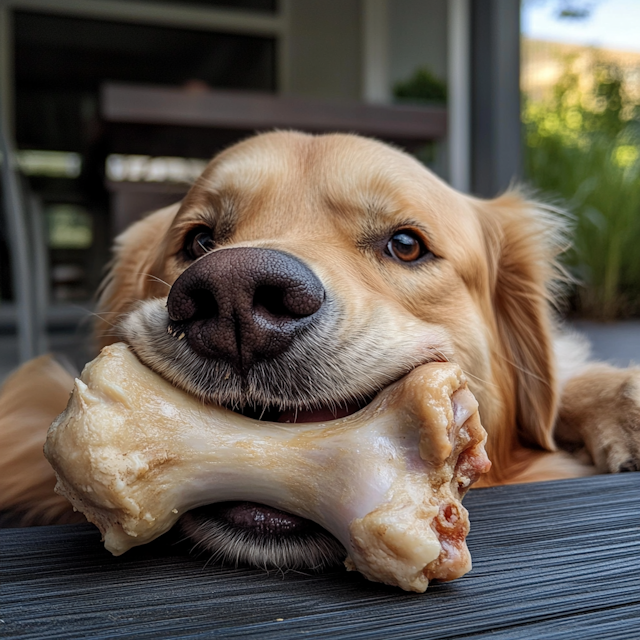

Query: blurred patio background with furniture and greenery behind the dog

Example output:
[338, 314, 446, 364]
[0, 0, 640, 380]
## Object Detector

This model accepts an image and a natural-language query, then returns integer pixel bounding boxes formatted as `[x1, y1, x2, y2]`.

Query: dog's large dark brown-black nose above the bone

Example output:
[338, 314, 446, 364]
[167, 247, 325, 373]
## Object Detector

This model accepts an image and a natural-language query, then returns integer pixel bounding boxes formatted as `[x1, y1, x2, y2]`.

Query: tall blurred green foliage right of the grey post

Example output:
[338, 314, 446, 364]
[523, 60, 640, 320]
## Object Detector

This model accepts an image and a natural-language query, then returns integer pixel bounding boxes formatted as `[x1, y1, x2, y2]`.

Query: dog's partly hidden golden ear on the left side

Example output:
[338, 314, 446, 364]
[94, 203, 180, 348]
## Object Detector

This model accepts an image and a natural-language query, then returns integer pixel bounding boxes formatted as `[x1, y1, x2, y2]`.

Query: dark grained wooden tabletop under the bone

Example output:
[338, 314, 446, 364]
[0, 473, 640, 640]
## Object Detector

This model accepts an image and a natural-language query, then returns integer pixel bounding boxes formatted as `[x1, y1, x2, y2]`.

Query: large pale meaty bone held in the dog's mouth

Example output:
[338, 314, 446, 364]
[45, 344, 490, 592]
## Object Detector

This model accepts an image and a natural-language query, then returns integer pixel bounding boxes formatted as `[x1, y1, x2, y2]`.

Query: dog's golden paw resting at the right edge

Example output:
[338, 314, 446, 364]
[556, 364, 640, 473]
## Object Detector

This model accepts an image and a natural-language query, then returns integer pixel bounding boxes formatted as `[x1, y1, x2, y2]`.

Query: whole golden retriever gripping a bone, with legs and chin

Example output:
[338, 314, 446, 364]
[0, 132, 640, 566]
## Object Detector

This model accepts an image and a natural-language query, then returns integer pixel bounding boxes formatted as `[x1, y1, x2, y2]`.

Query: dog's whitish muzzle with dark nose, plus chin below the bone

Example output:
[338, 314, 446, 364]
[114, 247, 450, 569]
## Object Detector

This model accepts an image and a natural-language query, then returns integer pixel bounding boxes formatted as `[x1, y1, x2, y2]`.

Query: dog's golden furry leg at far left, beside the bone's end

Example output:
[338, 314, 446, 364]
[0, 356, 84, 525]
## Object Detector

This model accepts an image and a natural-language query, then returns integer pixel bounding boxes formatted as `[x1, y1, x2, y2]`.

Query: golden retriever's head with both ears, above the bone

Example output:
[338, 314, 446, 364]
[101, 132, 556, 564]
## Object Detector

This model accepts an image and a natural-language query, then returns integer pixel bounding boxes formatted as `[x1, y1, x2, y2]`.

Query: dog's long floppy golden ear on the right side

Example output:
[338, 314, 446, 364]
[480, 193, 563, 451]
